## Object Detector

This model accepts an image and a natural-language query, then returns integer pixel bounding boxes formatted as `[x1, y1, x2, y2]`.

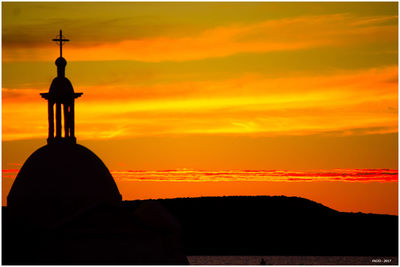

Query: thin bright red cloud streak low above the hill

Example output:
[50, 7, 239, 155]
[2, 169, 398, 182]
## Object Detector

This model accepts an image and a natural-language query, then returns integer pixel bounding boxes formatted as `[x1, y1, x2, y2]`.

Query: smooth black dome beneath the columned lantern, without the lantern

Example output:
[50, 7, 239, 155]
[7, 143, 121, 229]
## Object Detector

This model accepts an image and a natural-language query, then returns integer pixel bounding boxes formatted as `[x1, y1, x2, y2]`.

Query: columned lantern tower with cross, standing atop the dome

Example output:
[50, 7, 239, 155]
[40, 30, 83, 144]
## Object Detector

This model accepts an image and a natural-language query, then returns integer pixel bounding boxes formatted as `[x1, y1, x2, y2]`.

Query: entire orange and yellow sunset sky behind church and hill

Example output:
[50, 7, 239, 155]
[2, 2, 398, 214]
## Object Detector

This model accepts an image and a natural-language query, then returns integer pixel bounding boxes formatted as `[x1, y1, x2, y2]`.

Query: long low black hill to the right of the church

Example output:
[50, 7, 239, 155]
[124, 196, 398, 256]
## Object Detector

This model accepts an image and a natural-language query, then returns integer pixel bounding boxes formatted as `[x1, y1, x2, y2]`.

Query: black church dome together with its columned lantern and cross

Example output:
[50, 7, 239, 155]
[7, 30, 122, 227]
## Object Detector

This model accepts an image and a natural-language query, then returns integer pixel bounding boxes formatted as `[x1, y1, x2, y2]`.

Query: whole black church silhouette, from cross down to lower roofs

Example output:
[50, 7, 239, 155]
[2, 30, 188, 265]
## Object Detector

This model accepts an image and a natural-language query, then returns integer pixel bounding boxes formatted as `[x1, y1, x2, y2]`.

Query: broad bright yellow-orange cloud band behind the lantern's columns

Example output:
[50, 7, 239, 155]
[3, 67, 398, 140]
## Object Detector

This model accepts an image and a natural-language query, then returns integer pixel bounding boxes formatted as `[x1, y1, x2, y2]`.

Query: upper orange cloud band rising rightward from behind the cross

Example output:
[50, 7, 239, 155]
[3, 14, 397, 62]
